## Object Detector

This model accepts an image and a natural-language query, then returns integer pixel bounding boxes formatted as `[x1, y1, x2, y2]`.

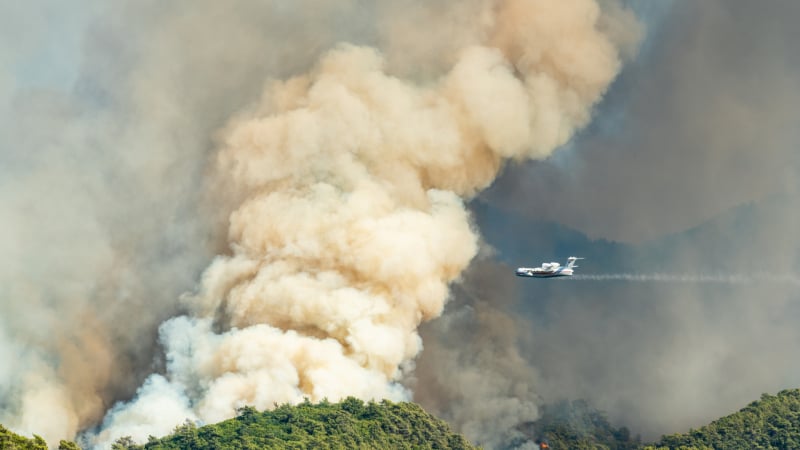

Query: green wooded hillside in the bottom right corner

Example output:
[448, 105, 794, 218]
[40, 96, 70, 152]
[657, 389, 800, 450]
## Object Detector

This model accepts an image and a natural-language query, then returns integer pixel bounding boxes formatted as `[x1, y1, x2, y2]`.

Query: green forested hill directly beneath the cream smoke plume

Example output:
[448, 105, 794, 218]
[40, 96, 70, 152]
[115, 398, 476, 450]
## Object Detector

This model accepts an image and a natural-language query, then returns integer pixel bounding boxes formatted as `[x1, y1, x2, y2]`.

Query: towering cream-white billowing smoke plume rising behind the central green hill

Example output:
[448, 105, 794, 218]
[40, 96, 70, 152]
[83, 0, 632, 445]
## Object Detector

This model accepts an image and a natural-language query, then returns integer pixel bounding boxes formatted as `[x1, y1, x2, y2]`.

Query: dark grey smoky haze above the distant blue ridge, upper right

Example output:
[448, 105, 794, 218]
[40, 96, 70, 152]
[487, 1, 800, 242]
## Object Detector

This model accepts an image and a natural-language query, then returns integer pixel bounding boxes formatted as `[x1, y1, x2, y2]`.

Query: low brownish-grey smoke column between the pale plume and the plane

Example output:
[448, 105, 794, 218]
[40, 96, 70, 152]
[406, 255, 541, 448]
